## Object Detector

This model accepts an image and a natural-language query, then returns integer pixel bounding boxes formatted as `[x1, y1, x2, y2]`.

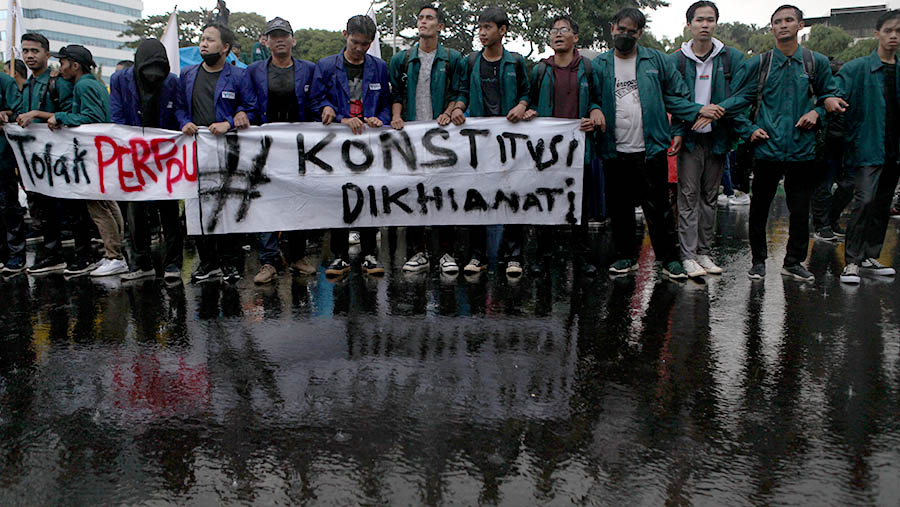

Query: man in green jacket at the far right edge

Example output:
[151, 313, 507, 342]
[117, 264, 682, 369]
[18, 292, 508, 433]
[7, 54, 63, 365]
[838, 10, 900, 284]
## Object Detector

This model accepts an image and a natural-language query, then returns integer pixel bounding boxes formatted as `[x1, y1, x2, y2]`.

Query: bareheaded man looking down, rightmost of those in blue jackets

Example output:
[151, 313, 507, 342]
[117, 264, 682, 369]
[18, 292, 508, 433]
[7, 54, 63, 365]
[312, 15, 391, 277]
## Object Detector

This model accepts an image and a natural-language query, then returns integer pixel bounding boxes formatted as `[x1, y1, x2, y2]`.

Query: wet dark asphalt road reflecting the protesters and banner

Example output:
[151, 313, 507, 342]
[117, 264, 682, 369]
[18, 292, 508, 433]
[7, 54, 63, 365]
[0, 198, 900, 505]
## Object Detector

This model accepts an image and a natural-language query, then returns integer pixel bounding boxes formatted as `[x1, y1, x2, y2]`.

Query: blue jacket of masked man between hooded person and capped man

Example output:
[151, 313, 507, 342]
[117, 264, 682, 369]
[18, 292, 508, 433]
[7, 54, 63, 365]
[175, 64, 256, 130]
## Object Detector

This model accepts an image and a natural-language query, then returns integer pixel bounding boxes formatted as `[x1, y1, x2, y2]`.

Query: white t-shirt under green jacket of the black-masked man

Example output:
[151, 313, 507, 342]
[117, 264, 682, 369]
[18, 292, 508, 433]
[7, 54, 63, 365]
[615, 55, 644, 153]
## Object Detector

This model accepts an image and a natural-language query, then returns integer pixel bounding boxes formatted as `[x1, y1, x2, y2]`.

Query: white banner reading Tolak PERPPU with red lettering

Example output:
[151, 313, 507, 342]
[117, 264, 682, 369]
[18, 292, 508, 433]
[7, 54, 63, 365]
[3, 124, 197, 201]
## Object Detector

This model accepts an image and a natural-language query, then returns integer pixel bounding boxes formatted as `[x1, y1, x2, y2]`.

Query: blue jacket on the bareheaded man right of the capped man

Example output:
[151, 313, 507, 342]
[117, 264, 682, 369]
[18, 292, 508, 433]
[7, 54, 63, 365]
[312, 50, 391, 125]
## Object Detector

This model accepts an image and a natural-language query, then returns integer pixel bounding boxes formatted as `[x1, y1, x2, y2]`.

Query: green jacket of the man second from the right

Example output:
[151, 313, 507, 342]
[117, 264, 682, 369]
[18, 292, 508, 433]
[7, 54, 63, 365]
[736, 46, 837, 162]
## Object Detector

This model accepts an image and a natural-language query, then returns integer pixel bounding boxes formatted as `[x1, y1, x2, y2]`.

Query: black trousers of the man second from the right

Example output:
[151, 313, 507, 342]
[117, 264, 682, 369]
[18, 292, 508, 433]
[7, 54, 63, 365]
[750, 160, 816, 266]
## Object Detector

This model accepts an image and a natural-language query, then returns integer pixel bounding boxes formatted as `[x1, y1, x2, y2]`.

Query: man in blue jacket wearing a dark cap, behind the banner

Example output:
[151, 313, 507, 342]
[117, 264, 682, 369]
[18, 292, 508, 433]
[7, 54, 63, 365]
[247, 17, 316, 284]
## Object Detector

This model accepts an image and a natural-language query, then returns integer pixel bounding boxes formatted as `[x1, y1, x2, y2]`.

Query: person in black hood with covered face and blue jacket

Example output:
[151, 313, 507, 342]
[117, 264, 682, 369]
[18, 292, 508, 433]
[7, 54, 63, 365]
[109, 39, 184, 280]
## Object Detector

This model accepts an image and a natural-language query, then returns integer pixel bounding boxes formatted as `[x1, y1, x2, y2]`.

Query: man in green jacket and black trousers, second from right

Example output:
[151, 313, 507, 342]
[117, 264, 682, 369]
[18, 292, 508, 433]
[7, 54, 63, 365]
[735, 5, 845, 281]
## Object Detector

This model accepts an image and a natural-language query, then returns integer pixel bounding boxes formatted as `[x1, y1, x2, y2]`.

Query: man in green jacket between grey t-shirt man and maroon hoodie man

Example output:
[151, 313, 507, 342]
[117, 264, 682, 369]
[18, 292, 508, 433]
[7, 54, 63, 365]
[454, 7, 529, 277]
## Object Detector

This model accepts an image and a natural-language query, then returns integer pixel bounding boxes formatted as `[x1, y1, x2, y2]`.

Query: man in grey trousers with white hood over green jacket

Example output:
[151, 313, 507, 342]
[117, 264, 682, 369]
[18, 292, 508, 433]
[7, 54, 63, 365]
[669, 0, 747, 278]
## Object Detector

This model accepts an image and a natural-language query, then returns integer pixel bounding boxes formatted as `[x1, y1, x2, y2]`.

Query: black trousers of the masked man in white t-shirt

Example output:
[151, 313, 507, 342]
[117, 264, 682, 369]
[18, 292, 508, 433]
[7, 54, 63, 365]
[603, 152, 678, 263]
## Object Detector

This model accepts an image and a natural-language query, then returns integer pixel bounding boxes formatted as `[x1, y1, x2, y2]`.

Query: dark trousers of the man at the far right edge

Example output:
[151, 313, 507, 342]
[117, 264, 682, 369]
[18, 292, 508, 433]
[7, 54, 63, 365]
[844, 162, 900, 264]
